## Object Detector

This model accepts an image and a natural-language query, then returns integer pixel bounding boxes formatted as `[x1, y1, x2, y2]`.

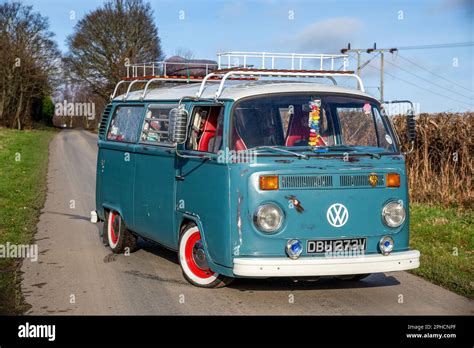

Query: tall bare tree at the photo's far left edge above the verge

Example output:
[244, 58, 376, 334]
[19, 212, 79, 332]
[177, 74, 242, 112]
[0, 2, 60, 129]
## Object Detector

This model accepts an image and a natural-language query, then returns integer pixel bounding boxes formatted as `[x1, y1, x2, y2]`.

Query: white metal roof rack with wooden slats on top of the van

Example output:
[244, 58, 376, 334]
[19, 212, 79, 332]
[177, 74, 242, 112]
[110, 52, 365, 100]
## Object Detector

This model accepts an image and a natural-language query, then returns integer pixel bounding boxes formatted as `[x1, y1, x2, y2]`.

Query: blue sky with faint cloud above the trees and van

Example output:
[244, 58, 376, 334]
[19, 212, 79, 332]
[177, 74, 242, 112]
[18, 0, 474, 112]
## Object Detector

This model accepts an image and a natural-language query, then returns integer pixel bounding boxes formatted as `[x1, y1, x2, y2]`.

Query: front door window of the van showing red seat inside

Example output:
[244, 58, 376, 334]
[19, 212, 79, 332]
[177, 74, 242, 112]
[186, 105, 224, 153]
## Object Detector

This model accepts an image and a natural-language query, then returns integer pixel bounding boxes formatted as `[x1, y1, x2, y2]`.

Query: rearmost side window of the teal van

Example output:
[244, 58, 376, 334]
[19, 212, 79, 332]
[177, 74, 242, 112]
[107, 105, 143, 143]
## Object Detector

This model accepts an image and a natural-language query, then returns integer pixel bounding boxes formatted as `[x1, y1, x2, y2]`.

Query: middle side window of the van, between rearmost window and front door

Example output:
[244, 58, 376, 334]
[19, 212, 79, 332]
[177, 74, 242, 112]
[140, 104, 177, 145]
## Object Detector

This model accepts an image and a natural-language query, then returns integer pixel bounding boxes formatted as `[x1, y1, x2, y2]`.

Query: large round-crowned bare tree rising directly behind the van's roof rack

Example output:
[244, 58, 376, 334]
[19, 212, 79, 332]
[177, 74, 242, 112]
[64, 0, 162, 100]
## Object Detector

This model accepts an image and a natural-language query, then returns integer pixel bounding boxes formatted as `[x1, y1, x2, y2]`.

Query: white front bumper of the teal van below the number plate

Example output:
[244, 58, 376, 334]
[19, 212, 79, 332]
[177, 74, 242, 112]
[234, 250, 420, 277]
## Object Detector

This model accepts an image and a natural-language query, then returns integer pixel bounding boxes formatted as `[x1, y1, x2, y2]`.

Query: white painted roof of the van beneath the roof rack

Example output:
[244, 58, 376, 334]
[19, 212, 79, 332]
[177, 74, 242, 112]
[114, 80, 376, 101]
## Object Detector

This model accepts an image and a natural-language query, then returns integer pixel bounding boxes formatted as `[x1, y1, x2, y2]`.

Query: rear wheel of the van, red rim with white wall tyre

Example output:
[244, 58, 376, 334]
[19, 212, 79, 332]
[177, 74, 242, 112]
[104, 210, 137, 254]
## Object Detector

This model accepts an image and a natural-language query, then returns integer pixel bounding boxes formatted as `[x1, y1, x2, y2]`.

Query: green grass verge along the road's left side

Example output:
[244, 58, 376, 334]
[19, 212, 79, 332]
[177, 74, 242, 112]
[0, 129, 54, 314]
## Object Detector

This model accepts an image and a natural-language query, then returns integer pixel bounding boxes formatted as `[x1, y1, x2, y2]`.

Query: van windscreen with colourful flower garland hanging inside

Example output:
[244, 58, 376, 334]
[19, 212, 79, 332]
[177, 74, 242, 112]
[231, 95, 395, 152]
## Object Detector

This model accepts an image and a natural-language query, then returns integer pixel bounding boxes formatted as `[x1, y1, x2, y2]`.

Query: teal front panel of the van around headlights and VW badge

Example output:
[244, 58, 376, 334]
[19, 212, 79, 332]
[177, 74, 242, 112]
[231, 156, 409, 257]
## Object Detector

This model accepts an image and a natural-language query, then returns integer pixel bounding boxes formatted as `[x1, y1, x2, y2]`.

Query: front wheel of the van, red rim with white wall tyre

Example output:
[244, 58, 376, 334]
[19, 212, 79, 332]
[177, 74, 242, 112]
[178, 224, 233, 288]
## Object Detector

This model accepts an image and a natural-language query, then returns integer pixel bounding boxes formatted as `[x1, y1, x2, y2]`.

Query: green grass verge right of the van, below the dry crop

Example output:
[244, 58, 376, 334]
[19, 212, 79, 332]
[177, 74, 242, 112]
[410, 204, 474, 298]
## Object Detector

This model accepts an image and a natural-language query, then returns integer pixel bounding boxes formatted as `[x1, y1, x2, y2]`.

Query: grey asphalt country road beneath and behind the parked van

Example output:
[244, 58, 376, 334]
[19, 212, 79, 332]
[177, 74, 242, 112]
[22, 130, 474, 315]
